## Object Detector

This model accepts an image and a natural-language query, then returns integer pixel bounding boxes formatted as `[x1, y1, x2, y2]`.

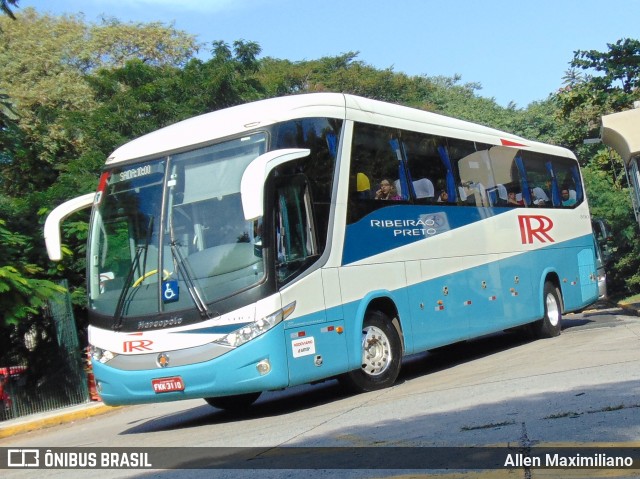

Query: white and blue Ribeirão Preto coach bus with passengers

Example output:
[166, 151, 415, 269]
[45, 93, 598, 409]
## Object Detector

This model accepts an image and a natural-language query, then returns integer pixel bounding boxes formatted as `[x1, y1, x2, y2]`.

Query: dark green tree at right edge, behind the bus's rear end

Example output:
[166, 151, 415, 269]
[555, 38, 640, 295]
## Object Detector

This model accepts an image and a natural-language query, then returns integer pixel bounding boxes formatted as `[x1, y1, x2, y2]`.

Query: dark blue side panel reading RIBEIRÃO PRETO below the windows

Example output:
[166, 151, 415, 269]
[342, 205, 512, 265]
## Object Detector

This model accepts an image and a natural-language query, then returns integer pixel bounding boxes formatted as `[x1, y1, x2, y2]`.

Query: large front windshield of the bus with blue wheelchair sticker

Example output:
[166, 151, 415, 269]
[88, 133, 266, 325]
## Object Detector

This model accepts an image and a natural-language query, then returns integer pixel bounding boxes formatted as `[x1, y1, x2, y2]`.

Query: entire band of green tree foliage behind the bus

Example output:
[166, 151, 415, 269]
[0, 8, 640, 334]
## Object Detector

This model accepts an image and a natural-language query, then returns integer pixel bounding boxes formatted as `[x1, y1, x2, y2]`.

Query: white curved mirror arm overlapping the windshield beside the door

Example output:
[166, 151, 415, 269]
[240, 148, 311, 221]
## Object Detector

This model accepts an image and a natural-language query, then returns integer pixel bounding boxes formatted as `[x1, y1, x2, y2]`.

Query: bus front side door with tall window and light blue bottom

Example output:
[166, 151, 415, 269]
[274, 175, 347, 385]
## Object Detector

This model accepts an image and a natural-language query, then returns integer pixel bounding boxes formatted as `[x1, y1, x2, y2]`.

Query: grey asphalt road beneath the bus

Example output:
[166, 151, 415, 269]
[0, 305, 640, 479]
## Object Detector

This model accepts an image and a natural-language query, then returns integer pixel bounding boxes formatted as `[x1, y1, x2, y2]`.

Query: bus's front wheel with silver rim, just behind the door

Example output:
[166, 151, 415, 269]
[340, 311, 402, 393]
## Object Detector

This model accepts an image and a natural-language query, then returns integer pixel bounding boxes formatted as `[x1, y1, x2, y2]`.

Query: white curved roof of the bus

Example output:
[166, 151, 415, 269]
[107, 93, 573, 165]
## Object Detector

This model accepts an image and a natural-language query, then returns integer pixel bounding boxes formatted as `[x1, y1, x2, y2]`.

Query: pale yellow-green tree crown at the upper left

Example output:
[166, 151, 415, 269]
[0, 9, 198, 194]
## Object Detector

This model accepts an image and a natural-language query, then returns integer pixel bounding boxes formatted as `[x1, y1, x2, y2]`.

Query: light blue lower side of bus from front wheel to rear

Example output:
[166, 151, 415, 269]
[342, 235, 598, 361]
